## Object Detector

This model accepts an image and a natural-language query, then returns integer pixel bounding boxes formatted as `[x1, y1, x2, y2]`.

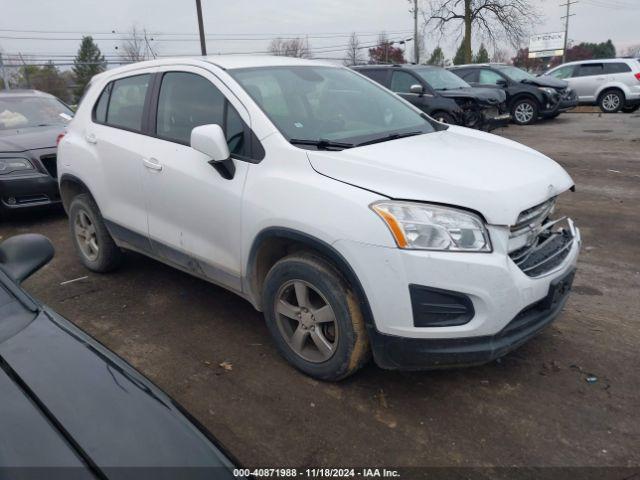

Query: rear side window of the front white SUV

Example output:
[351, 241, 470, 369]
[106, 74, 151, 132]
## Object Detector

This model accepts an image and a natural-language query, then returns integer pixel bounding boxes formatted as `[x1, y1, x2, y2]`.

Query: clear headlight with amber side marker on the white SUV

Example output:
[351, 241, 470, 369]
[371, 201, 491, 252]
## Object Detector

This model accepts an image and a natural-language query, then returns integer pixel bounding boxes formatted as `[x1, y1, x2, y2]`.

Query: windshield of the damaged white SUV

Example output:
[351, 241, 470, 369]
[229, 66, 434, 146]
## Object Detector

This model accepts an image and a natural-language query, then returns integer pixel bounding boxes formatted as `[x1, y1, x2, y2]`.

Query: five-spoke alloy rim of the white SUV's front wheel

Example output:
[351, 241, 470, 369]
[275, 280, 338, 363]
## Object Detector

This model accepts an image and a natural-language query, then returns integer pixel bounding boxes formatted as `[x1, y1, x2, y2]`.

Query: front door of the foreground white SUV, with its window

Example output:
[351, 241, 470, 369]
[143, 67, 250, 291]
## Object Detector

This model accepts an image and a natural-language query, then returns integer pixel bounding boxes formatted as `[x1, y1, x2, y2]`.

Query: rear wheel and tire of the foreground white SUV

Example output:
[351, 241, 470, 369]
[69, 193, 122, 273]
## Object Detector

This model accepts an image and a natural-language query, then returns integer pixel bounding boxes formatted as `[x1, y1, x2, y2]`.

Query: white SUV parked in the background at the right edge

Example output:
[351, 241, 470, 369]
[542, 58, 640, 113]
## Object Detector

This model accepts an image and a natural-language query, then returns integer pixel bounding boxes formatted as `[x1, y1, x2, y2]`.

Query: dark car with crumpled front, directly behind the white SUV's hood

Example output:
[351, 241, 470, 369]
[351, 65, 510, 131]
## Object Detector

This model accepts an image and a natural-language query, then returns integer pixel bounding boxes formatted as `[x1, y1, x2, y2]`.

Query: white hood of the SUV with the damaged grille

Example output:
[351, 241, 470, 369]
[308, 126, 573, 225]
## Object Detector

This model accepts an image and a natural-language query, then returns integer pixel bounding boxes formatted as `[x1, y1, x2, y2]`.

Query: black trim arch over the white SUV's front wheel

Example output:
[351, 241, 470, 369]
[243, 227, 375, 329]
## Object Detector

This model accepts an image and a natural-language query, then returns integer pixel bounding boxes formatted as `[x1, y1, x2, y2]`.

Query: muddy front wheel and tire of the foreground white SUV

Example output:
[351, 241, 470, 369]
[262, 253, 370, 381]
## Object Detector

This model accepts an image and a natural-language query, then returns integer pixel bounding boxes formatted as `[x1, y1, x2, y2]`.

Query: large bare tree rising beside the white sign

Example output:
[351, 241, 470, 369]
[424, 0, 540, 63]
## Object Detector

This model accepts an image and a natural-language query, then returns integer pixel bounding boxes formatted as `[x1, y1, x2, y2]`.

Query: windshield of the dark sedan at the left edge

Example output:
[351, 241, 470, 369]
[0, 96, 73, 130]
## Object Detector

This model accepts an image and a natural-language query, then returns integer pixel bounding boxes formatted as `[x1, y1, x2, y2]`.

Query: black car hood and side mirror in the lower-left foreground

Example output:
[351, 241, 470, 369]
[0, 234, 235, 479]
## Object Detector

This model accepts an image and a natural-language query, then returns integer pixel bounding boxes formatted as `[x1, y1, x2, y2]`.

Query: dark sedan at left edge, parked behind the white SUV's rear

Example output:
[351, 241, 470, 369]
[0, 90, 73, 216]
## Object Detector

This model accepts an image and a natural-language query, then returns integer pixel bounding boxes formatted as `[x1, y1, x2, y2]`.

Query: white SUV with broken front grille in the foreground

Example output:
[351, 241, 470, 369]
[58, 56, 580, 380]
